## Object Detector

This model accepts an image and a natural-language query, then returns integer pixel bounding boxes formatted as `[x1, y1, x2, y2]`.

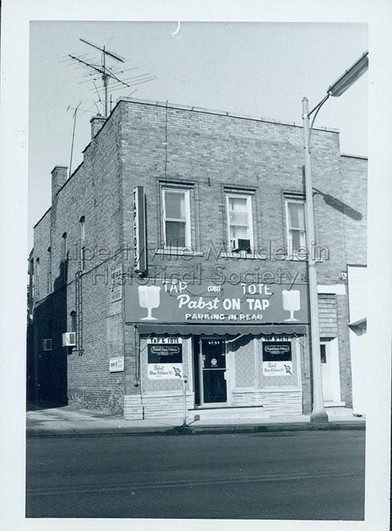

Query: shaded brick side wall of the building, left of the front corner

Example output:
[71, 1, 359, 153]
[34, 105, 124, 413]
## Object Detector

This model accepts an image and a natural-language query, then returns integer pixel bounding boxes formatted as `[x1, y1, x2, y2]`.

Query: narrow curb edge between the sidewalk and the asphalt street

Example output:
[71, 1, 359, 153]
[26, 422, 366, 438]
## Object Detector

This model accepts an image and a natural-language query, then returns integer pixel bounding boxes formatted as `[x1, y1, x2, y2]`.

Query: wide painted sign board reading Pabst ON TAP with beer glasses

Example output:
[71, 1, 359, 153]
[124, 279, 308, 324]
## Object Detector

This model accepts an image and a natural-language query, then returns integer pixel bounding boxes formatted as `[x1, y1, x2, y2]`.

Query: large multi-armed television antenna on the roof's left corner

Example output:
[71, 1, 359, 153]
[68, 39, 157, 118]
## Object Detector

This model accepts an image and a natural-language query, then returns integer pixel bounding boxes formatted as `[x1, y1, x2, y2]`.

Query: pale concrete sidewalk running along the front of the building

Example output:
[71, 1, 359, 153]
[26, 406, 365, 437]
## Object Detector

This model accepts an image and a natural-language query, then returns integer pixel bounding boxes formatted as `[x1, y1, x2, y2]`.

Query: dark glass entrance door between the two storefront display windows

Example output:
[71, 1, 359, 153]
[201, 339, 227, 404]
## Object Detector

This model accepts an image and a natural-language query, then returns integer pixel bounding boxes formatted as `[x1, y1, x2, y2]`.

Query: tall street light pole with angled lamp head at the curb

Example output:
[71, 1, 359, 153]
[302, 52, 369, 422]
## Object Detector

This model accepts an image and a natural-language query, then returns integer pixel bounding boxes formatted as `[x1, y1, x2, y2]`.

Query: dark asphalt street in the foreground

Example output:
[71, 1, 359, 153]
[26, 430, 365, 520]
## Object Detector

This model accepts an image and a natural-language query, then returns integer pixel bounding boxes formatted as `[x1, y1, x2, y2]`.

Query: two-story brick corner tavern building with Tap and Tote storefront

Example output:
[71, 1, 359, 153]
[28, 100, 366, 420]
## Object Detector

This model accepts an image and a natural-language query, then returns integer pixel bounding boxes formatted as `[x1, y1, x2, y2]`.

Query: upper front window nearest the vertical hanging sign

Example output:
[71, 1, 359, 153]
[162, 187, 191, 248]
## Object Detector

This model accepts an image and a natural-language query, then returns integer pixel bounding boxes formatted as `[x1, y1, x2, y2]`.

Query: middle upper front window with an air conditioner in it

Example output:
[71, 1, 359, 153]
[226, 193, 254, 253]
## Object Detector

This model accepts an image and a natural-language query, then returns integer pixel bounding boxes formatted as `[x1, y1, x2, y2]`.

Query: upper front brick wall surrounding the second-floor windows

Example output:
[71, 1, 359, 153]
[120, 101, 358, 290]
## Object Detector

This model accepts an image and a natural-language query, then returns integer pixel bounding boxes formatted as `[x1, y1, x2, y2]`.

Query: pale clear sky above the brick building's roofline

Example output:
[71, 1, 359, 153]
[29, 21, 368, 240]
